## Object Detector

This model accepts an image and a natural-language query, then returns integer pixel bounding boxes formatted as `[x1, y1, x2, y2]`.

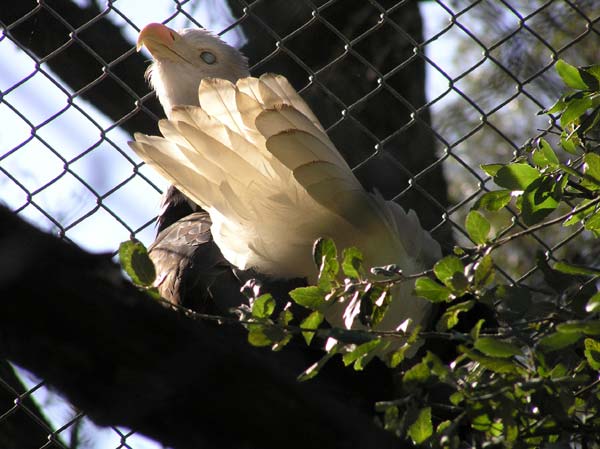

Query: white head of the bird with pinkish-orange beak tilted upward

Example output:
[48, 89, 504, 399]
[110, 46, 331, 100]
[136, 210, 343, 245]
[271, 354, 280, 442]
[137, 23, 250, 116]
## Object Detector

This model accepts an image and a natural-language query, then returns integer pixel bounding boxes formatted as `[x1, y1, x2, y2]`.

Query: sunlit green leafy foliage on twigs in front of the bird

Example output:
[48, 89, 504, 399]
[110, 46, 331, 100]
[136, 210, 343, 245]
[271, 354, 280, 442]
[121, 61, 600, 449]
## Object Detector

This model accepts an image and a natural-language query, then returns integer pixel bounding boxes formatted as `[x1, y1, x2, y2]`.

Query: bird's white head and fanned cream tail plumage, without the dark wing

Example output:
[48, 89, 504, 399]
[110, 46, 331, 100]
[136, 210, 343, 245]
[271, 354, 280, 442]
[130, 24, 441, 351]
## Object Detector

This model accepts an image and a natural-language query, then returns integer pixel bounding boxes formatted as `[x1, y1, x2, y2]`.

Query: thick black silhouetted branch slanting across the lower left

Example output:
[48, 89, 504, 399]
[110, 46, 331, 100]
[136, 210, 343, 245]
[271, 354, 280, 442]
[0, 209, 398, 449]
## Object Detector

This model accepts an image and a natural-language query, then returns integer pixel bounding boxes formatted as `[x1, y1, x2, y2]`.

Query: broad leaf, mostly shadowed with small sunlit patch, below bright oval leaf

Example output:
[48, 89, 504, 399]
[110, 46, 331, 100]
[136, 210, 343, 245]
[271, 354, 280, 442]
[521, 177, 562, 226]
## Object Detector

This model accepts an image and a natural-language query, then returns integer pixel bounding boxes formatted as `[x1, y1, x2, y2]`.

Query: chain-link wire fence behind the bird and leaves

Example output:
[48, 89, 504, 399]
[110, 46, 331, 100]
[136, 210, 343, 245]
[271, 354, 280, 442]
[0, 0, 600, 448]
